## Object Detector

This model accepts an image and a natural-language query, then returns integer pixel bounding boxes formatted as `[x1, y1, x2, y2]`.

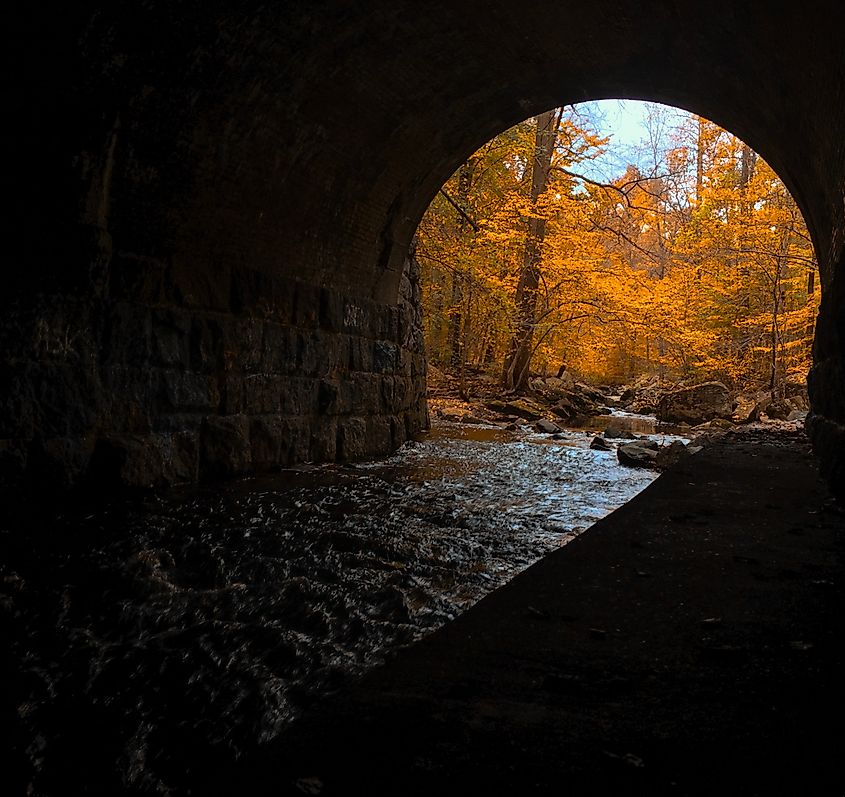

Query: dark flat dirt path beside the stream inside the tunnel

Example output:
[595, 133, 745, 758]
[224, 432, 845, 796]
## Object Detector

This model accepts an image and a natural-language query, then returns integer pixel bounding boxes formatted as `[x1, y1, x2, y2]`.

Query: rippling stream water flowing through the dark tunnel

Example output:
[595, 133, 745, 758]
[0, 416, 674, 794]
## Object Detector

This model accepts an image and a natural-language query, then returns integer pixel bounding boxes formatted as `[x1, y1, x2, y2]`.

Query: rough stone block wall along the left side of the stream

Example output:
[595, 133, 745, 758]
[0, 253, 428, 494]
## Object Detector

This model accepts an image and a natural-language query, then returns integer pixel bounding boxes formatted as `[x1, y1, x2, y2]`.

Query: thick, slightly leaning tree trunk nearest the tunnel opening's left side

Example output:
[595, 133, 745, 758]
[502, 110, 560, 391]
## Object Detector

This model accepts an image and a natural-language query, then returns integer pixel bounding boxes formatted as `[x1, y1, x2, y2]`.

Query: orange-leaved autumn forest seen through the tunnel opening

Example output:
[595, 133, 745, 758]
[417, 106, 818, 398]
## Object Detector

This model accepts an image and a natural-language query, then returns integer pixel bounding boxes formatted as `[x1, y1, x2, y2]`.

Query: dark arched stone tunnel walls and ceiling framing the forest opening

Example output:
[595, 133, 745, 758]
[6, 0, 845, 496]
